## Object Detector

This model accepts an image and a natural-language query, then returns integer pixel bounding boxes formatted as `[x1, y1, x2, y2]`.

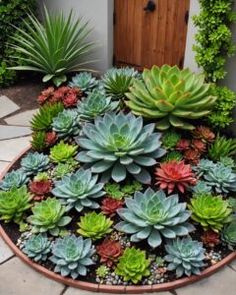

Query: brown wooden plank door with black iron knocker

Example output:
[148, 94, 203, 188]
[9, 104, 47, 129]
[114, 0, 190, 70]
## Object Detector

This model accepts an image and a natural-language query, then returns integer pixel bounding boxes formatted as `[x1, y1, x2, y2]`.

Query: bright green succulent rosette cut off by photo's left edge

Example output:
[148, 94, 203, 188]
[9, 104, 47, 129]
[0, 186, 32, 224]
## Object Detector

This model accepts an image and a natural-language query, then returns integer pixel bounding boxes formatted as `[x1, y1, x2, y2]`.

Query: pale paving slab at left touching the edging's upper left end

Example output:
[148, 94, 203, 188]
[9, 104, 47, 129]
[0, 137, 31, 162]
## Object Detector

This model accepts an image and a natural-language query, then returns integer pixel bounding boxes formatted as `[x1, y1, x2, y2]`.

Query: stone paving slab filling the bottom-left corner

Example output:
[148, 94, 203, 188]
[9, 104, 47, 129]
[0, 257, 64, 295]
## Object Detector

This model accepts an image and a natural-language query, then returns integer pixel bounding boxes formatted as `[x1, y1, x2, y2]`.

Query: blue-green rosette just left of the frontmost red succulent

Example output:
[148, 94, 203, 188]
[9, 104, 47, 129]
[50, 235, 95, 279]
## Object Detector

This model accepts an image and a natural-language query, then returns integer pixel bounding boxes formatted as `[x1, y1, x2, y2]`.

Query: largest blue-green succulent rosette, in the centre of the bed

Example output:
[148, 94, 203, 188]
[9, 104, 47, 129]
[76, 113, 165, 183]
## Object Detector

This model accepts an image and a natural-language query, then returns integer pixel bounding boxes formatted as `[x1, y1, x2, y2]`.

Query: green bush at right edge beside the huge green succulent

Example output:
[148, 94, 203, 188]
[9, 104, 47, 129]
[208, 86, 236, 128]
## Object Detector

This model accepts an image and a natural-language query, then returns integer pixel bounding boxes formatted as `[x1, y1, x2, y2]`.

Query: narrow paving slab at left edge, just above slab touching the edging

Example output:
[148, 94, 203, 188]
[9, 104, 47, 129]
[0, 125, 32, 140]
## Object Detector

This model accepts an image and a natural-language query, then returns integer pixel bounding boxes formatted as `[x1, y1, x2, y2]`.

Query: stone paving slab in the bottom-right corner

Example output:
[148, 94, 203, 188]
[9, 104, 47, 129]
[176, 266, 236, 295]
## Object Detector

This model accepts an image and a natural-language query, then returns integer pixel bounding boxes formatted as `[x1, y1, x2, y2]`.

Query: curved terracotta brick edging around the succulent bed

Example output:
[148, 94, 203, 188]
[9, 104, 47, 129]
[0, 147, 236, 294]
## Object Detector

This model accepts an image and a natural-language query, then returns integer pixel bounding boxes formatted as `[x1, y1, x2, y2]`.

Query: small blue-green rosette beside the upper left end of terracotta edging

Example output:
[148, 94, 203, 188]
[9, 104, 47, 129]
[21, 152, 49, 175]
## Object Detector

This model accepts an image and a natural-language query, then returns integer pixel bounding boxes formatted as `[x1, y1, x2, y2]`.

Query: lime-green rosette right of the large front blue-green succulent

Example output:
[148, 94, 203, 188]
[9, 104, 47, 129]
[189, 194, 232, 232]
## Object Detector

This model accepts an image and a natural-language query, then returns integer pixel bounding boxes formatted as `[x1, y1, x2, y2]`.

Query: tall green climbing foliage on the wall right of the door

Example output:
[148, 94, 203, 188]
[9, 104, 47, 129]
[194, 0, 236, 82]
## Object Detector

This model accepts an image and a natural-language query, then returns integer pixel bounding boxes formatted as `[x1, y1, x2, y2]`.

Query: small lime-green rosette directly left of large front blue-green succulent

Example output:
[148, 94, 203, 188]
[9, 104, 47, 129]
[77, 211, 113, 240]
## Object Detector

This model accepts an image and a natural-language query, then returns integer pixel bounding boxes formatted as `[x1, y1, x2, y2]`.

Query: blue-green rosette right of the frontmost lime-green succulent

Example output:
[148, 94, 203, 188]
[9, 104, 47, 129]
[164, 238, 205, 278]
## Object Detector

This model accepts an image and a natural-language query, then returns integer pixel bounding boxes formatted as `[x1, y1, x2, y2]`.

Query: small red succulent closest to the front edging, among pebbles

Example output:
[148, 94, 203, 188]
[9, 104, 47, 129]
[97, 239, 122, 267]
